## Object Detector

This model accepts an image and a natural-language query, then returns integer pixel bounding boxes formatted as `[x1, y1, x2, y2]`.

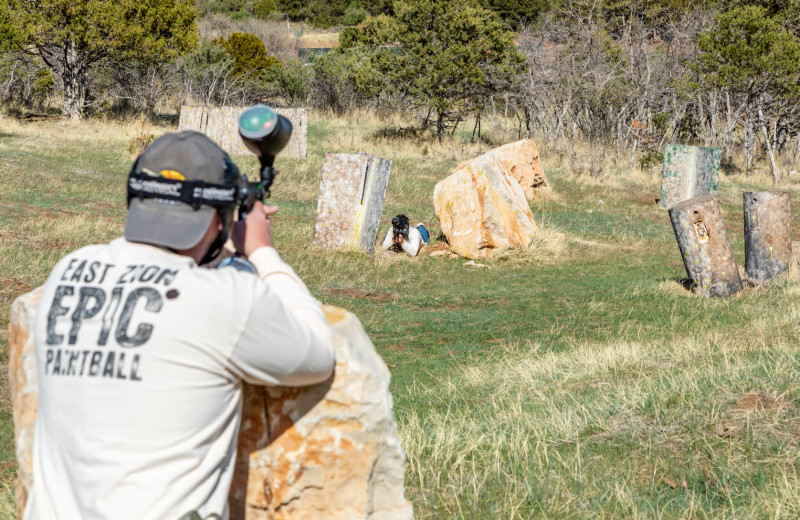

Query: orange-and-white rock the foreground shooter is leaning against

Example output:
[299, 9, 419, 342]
[9, 289, 413, 520]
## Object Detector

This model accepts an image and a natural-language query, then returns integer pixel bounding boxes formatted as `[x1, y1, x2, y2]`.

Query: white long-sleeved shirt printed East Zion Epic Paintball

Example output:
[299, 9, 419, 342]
[25, 239, 334, 520]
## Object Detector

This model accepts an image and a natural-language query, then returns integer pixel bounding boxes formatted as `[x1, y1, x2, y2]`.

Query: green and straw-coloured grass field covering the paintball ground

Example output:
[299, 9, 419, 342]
[0, 109, 800, 520]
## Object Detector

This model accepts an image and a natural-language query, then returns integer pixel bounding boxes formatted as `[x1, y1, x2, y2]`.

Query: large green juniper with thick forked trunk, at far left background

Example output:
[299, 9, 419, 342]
[0, 0, 198, 118]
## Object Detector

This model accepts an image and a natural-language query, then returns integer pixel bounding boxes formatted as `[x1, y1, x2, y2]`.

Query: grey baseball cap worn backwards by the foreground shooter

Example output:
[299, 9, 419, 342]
[125, 130, 235, 249]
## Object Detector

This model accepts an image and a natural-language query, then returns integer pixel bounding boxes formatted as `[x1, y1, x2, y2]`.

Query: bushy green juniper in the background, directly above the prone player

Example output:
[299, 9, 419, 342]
[340, 0, 524, 139]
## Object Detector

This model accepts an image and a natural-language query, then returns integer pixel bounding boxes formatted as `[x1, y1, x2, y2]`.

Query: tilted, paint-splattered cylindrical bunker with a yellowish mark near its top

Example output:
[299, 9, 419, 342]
[669, 195, 742, 297]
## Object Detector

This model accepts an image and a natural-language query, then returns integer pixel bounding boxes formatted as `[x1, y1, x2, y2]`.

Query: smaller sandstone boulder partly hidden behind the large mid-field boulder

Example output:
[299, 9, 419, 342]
[453, 139, 550, 200]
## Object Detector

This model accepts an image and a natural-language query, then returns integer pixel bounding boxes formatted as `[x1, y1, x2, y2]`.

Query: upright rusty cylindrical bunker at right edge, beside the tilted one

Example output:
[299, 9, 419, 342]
[743, 191, 792, 282]
